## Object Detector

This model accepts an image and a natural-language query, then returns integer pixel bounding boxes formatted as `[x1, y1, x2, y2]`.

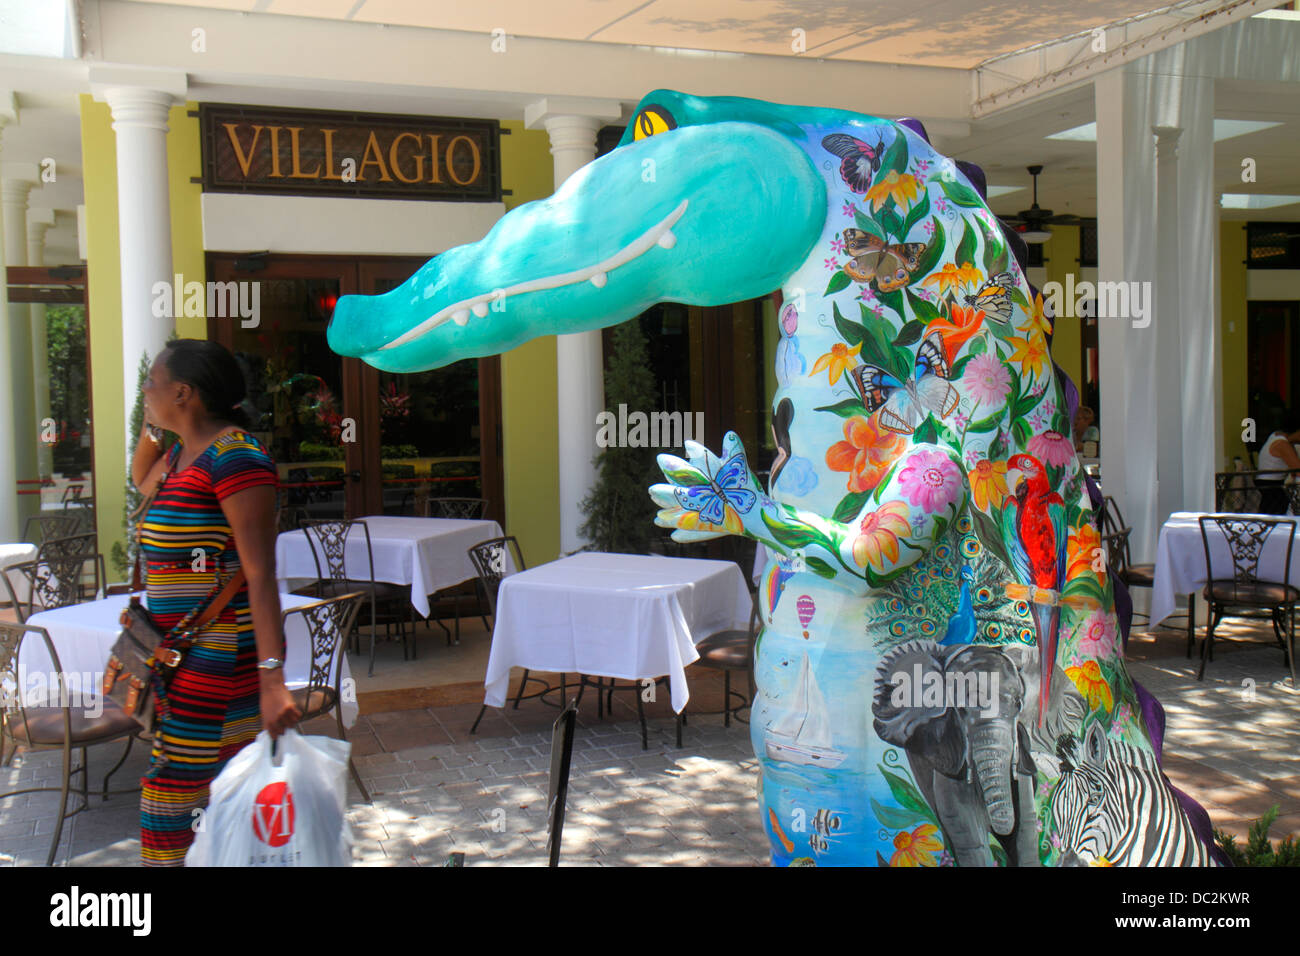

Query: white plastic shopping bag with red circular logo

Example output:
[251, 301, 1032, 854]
[185, 730, 352, 866]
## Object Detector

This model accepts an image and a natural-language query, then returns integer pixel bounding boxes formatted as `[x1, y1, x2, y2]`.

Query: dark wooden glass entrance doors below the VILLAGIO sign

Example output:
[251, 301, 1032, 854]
[208, 252, 504, 527]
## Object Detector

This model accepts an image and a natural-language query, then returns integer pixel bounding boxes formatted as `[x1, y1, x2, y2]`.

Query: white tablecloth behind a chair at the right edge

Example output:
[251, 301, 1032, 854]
[1151, 511, 1300, 624]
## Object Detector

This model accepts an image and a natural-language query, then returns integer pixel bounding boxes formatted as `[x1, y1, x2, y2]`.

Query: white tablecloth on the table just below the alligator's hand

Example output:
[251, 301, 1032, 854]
[484, 551, 753, 711]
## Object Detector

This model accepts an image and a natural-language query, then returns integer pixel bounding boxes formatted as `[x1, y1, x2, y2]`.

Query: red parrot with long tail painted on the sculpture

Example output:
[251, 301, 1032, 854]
[1002, 454, 1066, 727]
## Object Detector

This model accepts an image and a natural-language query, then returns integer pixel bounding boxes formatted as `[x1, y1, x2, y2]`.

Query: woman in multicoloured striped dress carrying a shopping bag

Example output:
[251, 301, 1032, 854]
[131, 338, 302, 866]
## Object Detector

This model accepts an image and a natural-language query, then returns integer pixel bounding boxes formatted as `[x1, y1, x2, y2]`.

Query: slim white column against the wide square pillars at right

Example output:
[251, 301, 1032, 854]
[1152, 126, 1183, 524]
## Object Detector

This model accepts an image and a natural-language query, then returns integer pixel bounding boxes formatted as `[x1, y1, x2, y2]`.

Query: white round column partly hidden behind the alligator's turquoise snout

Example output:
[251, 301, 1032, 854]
[524, 98, 623, 553]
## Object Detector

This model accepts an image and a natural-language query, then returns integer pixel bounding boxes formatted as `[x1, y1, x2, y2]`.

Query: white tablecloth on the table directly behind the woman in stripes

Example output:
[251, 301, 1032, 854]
[18, 594, 358, 727]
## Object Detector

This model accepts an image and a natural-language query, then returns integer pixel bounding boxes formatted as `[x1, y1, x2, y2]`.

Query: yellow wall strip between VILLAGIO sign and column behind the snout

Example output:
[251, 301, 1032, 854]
[501, 120, 560, 564]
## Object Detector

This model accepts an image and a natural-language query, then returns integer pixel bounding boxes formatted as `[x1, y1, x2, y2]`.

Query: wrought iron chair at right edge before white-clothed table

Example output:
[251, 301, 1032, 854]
[1196, 515, 1300, 687]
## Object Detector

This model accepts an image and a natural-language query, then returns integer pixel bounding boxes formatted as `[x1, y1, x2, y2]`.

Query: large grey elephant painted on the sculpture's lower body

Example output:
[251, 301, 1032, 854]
[872, 641, 1084, 866]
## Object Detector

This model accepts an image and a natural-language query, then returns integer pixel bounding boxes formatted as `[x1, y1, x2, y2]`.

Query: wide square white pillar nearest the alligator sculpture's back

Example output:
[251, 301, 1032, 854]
[1093, 68, 1160, 562]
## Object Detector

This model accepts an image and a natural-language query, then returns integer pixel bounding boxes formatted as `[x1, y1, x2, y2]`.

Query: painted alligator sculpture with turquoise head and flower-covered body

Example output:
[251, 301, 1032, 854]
[329, 90, 1218, 866]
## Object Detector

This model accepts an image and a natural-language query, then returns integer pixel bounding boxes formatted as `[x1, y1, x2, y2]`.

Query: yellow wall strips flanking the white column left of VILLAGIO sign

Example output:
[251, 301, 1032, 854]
[81, 94, 207, 580]
